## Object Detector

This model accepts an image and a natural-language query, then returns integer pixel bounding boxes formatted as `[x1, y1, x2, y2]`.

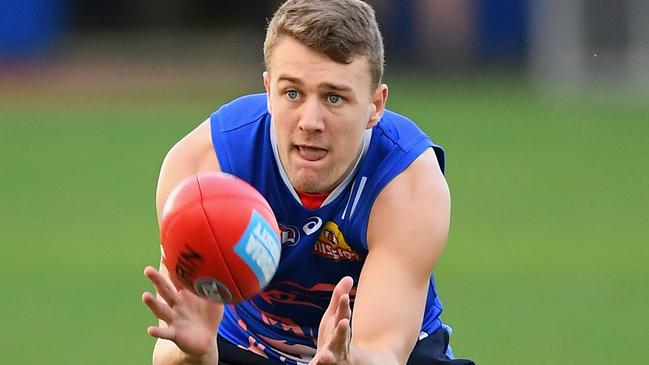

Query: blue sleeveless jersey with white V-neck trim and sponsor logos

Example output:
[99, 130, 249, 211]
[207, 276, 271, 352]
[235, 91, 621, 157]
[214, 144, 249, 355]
[210, 94, 444, 364]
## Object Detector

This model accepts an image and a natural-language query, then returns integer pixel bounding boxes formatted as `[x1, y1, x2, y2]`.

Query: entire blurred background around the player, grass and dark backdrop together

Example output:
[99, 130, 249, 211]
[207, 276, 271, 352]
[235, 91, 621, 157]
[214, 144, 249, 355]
[0, 0, 649, 364]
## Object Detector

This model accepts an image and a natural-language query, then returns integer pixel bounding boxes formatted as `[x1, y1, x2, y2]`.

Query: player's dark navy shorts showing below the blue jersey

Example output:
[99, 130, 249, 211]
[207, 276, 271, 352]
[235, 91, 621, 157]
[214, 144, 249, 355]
[217, 327, 475, 365]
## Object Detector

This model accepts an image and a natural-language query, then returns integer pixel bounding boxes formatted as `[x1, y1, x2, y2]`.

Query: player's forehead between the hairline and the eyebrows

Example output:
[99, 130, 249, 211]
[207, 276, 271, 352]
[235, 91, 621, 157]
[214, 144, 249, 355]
[268, 36, 371, 89]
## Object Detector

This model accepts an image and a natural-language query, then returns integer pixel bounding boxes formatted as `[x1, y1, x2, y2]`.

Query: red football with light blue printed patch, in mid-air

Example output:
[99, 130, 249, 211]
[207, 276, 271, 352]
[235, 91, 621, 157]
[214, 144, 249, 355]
[160, 172, 281, 303]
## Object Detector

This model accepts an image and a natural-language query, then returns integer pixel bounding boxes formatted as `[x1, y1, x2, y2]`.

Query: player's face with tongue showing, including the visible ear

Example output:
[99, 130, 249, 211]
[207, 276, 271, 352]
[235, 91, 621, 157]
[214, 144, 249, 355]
[264, 36, 387, 193]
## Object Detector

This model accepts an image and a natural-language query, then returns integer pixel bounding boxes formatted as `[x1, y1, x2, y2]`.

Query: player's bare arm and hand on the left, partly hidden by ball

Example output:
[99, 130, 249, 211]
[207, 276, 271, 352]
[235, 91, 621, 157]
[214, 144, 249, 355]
[142, 121, 223, 365]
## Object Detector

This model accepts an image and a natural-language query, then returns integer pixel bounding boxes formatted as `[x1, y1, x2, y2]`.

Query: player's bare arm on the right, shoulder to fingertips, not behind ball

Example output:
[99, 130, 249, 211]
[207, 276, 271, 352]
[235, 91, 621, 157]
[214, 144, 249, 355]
[313, 146, 450, 364]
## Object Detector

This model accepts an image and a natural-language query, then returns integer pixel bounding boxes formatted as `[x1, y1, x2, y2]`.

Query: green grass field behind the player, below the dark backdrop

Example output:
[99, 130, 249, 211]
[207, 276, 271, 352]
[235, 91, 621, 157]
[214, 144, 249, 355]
[0, 72, 649, 365]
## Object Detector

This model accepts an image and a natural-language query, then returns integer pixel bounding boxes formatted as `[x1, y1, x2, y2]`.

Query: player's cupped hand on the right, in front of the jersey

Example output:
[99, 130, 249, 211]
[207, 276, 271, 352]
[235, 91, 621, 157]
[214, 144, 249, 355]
[309, 276, 354, 365]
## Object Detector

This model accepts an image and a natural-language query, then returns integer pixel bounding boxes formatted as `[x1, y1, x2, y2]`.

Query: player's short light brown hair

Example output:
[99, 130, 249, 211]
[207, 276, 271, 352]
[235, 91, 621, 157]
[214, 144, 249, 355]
[264, 0, 384, 86]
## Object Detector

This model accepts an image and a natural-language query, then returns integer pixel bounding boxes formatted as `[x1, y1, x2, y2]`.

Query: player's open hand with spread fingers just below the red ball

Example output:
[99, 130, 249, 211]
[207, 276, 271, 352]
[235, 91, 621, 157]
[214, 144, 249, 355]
[142, 266, 223, 356]
